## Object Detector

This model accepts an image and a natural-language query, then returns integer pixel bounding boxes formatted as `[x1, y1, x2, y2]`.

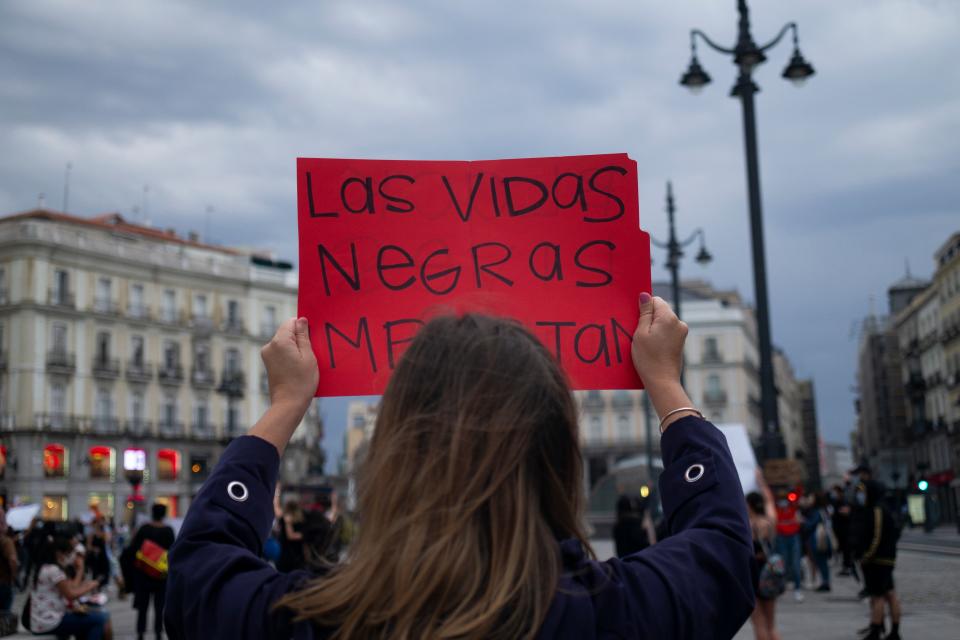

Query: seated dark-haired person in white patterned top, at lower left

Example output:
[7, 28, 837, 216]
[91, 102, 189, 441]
[29, 535, 113, 640]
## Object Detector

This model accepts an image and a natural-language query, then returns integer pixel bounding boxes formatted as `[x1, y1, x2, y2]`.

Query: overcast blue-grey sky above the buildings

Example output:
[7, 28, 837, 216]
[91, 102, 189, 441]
[0, 0, 960, 470]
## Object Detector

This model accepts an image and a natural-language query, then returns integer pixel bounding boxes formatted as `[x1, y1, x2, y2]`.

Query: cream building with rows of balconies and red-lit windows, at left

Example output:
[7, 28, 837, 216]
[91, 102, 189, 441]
[0, 209, 323, 519]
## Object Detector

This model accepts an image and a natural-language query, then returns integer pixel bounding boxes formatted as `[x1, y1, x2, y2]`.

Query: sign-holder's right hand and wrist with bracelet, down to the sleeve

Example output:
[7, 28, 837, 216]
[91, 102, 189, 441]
[630, 293, 695, 431]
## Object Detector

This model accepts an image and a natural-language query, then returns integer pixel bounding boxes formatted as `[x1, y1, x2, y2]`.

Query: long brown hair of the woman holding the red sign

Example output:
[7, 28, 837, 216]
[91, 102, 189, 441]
[277, 314, 592, 639]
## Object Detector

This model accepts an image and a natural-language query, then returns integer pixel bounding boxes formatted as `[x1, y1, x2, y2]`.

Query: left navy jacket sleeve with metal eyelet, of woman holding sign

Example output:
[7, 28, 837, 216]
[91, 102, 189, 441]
[164, 436, 312, 640]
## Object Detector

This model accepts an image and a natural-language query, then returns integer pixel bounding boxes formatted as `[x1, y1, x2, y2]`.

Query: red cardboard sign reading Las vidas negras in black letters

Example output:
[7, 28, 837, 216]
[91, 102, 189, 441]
[297, 154, 650, 396]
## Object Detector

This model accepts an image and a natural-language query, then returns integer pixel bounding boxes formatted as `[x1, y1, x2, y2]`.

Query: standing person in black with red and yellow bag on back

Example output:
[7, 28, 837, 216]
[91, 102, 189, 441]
[130, 504, 174, 640]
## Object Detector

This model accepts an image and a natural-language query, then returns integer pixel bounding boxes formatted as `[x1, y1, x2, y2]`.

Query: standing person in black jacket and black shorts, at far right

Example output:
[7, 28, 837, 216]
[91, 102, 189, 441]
[854, 480, 900, 640]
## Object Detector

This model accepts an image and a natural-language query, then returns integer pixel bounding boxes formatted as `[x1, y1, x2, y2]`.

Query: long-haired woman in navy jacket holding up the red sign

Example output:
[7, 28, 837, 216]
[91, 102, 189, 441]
[166, 302, 754, 639]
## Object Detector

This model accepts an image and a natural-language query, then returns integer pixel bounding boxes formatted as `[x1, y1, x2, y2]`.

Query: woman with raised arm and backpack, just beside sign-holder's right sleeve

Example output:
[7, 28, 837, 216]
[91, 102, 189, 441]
[747, 469, 782, 640]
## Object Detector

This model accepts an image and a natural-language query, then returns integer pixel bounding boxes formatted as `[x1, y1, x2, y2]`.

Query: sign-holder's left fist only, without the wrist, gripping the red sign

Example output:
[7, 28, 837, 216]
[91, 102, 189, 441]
[260, 318, 320, 410]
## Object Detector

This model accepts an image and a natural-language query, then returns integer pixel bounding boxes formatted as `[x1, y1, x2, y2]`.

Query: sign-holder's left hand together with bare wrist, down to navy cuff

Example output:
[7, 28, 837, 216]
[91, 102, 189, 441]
[250, 318, 320, 455]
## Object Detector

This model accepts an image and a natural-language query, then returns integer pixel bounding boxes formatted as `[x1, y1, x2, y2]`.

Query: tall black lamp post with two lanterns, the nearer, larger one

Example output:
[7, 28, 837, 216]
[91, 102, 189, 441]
[680, 0, 814, 459]
